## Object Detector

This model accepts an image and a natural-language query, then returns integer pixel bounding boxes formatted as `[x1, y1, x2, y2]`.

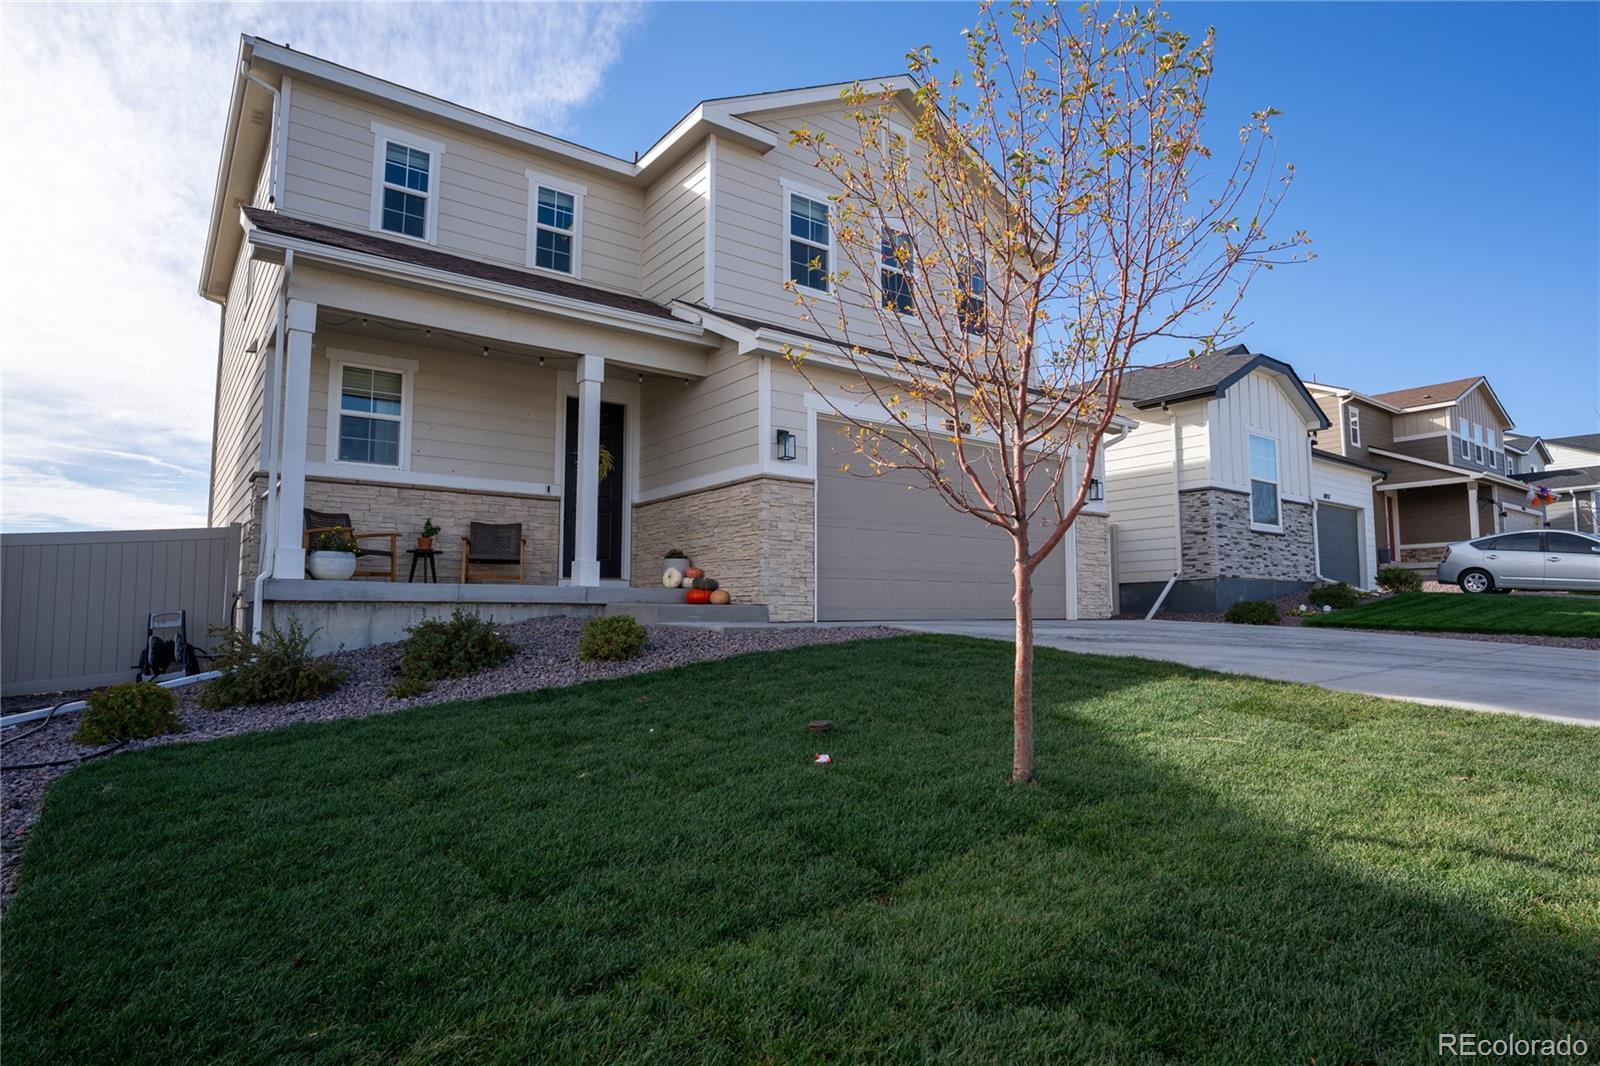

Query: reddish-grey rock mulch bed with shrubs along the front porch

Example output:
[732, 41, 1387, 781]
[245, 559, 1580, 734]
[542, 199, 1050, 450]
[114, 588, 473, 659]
[0, 618, 901, 906]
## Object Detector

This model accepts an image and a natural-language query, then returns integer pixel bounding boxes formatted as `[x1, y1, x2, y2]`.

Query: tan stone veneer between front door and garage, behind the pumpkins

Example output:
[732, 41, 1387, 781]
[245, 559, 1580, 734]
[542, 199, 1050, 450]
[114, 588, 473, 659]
[632, 477, 816, 621]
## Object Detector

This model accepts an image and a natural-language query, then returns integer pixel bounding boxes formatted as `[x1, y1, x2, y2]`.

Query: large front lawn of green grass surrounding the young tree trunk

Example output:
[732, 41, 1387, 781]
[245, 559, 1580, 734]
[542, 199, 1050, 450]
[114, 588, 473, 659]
[3, 637, 1600, 1066]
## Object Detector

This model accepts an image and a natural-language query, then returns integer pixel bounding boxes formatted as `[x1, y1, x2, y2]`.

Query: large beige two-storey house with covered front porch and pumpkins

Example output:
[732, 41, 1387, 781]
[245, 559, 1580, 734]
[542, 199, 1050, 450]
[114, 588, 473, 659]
[200, 37, 1110, 630]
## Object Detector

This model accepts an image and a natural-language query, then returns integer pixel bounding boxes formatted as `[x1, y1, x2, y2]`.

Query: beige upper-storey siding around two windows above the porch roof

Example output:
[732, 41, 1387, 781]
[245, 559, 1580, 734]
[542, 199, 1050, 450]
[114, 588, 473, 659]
[282, 83, 643, 293]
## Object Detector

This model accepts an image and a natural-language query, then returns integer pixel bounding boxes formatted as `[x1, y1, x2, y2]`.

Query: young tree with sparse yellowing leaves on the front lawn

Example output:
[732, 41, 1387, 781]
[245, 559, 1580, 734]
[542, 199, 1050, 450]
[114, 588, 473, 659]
[789, 0, 1309, 783]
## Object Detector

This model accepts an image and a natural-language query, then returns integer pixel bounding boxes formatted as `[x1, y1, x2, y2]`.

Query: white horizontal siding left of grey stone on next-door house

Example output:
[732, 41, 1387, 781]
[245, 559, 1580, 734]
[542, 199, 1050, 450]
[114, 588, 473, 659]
[1106, 411, 1178, 583]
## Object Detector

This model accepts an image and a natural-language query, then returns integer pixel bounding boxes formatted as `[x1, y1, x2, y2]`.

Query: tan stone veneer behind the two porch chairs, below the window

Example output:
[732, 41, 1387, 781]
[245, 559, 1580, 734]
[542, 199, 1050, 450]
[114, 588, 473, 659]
[240, 474, 562, 602]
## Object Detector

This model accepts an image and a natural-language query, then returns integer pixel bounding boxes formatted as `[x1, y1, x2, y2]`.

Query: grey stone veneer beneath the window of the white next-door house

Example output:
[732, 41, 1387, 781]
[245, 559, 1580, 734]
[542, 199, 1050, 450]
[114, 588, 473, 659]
[1178, 488, 1317, 581]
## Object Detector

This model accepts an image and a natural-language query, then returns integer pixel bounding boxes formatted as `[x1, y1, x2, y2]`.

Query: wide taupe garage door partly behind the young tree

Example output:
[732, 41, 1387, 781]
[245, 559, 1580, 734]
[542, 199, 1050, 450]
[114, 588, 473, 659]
[816, 423, 1067, 621]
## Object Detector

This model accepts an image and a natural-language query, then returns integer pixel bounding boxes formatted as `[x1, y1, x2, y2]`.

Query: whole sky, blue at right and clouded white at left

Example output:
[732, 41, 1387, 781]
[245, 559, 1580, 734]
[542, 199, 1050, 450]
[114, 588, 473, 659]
[0, 2, 1600, 530]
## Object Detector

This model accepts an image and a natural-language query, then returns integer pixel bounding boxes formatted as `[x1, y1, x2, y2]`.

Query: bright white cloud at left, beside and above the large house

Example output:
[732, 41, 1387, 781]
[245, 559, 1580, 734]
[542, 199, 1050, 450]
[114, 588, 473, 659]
[0, 3, 640, 530]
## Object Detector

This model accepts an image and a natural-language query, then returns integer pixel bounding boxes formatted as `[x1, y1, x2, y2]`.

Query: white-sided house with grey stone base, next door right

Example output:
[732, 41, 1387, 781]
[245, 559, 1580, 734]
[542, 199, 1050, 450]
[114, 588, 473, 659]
[1106, 344, 1382, 613]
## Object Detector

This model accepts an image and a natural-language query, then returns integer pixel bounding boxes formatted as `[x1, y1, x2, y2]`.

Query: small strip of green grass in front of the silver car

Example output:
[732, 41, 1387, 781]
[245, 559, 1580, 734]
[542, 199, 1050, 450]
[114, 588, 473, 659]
[1306, 592, 1600, 637]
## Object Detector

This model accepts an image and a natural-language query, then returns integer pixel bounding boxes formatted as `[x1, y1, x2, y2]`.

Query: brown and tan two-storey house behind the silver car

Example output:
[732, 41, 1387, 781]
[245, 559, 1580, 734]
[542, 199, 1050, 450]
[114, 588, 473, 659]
[1307, 376, 1539, 568]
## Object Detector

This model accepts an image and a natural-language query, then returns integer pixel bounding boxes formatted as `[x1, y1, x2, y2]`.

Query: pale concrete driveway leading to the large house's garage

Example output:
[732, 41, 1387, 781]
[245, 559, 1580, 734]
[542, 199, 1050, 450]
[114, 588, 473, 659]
[889, 621, 1600, 725]
